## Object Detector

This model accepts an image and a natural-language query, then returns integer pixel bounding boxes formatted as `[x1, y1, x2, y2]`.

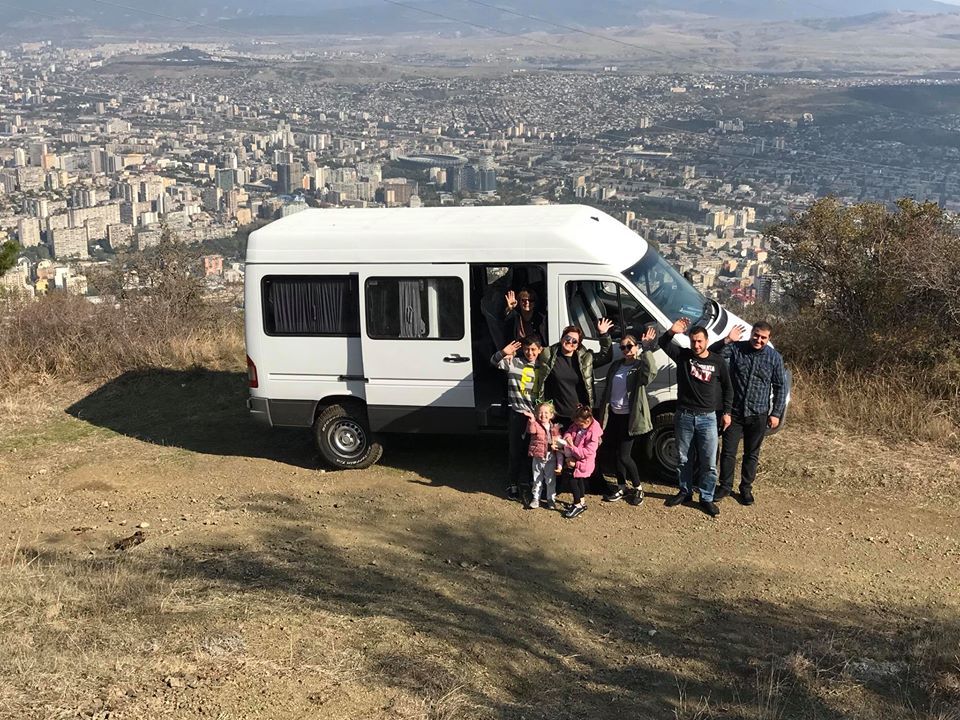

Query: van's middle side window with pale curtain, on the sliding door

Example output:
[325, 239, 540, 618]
[365, 277, 464, 340]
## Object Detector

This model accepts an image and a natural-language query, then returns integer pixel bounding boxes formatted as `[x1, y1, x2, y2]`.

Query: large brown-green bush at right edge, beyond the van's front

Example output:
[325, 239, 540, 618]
[767, 197, 960, 389]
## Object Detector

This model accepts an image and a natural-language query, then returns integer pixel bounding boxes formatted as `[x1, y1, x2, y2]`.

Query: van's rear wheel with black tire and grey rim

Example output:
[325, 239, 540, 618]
[313, 403, 383, 470]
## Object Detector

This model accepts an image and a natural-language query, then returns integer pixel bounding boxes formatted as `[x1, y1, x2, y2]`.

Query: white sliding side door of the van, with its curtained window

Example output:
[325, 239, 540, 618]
[360, 264, 477, 433]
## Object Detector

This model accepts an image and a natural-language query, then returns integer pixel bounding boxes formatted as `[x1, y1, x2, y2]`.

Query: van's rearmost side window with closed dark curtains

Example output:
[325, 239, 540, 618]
[261, 275, 360, 337]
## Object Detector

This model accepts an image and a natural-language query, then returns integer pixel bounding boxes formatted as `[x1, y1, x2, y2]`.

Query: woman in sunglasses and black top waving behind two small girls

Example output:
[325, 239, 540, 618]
[533, 318, 613, 427]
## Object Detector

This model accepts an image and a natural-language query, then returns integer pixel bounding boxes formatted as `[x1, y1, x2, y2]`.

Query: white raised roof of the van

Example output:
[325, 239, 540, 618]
[246, 205, 647, 269]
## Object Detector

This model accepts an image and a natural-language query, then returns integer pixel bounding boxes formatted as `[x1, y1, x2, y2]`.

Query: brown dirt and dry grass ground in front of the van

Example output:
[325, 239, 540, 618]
[0, 372, 960, 720]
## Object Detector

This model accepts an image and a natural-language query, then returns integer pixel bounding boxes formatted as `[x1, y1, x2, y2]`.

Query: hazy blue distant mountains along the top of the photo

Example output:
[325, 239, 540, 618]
[0, 0, 960, 42]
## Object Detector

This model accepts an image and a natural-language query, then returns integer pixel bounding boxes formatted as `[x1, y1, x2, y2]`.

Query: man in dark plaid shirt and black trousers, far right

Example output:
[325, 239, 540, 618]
[710, 321, 787, 505]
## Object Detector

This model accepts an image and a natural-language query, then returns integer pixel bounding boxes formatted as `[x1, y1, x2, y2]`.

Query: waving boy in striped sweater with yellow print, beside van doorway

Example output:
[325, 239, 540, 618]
[490, 335, 543, 500]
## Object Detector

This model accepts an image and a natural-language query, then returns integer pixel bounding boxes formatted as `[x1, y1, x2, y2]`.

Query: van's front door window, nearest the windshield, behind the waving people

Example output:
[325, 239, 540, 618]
[565, 280, 654, 339]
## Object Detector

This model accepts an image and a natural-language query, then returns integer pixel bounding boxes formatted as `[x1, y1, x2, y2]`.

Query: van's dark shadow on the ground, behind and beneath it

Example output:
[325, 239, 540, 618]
[67, 369, 672, 496]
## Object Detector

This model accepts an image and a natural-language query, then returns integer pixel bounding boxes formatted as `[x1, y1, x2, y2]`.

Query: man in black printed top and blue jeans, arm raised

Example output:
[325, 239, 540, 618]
[660, 318, 733, 517]
